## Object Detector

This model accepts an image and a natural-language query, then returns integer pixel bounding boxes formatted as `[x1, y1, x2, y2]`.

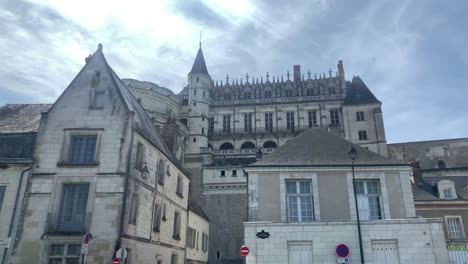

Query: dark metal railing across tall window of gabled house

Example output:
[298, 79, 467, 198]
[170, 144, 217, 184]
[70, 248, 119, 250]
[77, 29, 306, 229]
[47, 212, 91, 233]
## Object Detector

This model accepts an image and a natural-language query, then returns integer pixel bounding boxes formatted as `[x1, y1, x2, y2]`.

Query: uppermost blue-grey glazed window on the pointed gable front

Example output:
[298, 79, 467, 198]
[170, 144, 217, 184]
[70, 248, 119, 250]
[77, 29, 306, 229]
[68, 135, 97, 164]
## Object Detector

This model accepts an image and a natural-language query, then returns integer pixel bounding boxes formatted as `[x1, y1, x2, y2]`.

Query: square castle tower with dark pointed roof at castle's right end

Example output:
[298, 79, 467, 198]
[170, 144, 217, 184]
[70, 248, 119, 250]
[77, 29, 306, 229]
[343, 77, 387, 156]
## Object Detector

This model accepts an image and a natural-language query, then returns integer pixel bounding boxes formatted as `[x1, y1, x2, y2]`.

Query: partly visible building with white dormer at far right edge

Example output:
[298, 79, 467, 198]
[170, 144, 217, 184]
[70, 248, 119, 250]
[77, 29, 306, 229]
[388, 138, 468, 264]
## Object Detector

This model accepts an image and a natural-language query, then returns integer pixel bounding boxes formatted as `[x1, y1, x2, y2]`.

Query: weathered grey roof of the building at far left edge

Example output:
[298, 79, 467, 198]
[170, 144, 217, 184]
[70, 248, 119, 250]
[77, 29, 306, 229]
[0, 104, 51, 133]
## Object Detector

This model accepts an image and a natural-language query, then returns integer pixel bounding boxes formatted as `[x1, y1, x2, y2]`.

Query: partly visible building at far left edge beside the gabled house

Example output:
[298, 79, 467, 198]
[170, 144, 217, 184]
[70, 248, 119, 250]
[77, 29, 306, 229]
[0, 104, 50, 263]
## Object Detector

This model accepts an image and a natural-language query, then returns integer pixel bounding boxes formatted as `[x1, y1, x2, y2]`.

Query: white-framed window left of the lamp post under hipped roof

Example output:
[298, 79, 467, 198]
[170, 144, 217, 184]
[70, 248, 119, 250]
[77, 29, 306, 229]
[286, 180, 314, 222]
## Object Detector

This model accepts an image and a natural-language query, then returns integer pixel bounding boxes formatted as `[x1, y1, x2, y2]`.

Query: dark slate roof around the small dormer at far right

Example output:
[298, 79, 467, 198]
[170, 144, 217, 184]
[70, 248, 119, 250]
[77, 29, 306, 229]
[412, 176, 468, 201]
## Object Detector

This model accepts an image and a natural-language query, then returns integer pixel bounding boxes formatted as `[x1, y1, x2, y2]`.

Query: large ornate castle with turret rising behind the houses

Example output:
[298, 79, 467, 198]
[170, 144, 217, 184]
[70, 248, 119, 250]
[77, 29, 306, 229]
[123, 46, 387, 263]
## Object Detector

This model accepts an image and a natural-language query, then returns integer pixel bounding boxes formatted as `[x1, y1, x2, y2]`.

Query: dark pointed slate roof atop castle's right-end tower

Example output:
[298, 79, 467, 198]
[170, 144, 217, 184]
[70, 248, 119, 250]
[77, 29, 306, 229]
[343, 76, 381, 105]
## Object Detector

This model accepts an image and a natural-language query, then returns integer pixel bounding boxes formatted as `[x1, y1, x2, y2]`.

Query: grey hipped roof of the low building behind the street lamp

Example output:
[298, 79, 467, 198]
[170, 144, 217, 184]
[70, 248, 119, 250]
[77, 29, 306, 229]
[247, 128, 409, 167]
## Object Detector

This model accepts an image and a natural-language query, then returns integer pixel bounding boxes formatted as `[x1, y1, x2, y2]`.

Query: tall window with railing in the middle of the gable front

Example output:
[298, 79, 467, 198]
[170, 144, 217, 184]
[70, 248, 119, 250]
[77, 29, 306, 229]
[57, 183, 89, 232]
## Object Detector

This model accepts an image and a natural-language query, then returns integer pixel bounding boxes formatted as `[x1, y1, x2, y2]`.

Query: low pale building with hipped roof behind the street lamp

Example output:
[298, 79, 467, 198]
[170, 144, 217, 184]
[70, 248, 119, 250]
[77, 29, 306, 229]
[244, 128, 448, 264]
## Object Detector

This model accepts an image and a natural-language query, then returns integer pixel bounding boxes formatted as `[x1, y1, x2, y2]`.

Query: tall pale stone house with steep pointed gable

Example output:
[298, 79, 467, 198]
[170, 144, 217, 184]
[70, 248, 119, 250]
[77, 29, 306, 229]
[9, 45, 189, 264]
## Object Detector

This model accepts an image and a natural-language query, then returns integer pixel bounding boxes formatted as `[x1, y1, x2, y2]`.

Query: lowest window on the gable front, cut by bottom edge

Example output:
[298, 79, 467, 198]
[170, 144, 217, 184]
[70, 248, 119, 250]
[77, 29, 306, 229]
[48, 243, 81, 264]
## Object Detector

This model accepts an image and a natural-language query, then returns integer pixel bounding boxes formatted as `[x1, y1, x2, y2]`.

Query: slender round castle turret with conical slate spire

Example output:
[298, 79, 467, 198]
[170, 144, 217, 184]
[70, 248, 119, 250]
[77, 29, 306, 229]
[186, 44, 213, 154]
